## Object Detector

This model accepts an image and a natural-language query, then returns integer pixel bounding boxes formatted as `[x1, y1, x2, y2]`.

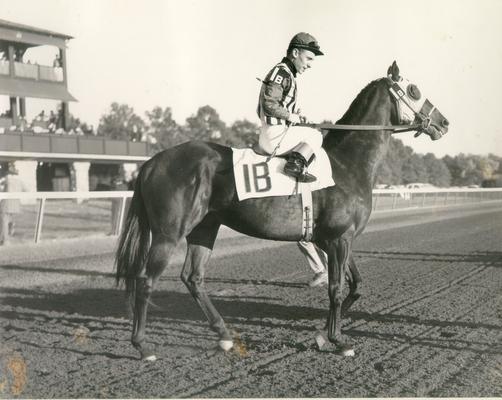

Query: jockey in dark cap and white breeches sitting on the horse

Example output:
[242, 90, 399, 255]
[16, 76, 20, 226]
[257, 32, 323, 182]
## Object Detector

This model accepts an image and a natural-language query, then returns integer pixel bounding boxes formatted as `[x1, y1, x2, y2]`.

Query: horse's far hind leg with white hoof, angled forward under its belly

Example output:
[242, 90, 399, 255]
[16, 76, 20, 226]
[181, 215, 233, 350]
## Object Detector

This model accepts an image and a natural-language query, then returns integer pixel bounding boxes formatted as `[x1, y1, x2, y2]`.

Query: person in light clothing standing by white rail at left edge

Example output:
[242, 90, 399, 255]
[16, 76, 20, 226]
[0, 163, 27, 245]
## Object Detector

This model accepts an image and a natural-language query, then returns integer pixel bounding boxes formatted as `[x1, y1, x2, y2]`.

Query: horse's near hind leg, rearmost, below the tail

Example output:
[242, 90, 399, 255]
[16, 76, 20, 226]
[131, 234, 176, 361]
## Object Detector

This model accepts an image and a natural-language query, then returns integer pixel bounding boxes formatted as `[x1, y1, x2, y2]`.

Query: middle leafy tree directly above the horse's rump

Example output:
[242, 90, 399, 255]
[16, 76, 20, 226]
[145, 107, 185, 153]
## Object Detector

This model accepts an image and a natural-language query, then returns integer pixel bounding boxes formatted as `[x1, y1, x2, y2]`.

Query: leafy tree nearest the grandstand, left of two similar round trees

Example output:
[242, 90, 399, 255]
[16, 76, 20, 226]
[98, 102, 145, 141]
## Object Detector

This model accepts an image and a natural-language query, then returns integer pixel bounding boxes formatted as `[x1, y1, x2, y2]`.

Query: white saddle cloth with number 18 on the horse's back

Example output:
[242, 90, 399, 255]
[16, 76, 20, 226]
[232, 148, 335, 200]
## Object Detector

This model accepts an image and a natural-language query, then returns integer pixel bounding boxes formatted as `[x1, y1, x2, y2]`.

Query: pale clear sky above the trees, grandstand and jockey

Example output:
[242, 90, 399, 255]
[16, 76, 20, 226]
[0, 0, 502, 157]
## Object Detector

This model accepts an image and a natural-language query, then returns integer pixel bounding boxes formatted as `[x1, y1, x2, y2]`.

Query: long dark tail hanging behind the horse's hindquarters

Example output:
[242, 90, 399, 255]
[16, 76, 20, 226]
[115, 174, 150, 300]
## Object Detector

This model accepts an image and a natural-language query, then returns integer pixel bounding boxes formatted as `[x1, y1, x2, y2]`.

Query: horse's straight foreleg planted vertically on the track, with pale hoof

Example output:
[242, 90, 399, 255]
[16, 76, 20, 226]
[328, 237, 354, 355]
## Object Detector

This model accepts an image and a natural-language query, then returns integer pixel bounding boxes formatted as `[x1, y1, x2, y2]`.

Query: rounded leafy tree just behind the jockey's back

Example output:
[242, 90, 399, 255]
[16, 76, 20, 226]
[184, 106, 226, 144]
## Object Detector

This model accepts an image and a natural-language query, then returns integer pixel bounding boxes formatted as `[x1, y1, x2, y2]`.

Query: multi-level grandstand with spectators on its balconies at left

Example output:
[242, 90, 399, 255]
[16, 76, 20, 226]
[0, 19, 149, 191]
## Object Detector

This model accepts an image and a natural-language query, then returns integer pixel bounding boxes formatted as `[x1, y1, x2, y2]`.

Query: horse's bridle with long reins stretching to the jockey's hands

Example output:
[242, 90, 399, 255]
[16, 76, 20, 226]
[298, 77, 435, 137]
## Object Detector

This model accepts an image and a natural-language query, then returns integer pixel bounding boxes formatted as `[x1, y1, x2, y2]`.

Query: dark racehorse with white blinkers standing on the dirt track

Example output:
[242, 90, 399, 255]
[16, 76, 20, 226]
[116, 62, 448, 360]
